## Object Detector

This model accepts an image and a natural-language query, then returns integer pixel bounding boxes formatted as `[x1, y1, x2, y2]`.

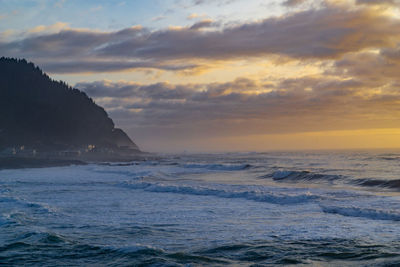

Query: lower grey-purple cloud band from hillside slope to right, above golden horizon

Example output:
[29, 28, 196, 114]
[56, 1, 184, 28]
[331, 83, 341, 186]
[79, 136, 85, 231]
[76, 77, 400, 140]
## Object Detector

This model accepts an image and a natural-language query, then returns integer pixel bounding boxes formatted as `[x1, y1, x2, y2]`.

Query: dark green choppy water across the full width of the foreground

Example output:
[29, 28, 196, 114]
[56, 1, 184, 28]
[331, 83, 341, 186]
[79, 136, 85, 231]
[0, 238, 399, 266]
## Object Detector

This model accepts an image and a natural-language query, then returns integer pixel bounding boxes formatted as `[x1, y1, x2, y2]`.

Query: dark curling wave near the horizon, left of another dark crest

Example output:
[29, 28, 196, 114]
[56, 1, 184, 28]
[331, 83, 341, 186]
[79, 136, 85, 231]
[262, 170, 342, 182]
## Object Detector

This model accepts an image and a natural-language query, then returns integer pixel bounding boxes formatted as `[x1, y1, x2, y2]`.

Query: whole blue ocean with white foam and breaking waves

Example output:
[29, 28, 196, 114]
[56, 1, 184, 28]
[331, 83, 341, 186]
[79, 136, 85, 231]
[0, 151, 400, 266]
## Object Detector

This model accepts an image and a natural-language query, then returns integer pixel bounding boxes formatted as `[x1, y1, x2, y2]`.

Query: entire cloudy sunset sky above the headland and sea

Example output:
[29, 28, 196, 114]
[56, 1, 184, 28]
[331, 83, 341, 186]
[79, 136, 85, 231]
[0, 0, 400, 152]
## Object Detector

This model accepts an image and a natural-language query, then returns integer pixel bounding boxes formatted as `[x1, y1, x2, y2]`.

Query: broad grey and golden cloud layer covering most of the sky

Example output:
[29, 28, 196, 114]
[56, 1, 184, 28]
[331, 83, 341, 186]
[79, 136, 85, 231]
[0, 0, 400, 151]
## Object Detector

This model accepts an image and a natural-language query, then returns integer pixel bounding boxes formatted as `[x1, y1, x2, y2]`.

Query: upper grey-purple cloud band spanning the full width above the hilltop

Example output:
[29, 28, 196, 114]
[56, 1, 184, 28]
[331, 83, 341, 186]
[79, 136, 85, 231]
[0, 5, 400, 72]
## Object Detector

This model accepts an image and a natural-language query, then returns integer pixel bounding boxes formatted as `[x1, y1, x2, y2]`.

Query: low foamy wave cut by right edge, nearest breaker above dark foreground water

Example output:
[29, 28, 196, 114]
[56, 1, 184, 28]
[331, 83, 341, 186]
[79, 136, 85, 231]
[320, 205, 400, 221]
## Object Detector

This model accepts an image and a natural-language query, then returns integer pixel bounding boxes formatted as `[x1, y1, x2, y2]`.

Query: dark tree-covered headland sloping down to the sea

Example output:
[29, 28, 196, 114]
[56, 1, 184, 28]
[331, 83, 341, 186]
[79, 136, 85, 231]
[0, 58, 139, 151]
